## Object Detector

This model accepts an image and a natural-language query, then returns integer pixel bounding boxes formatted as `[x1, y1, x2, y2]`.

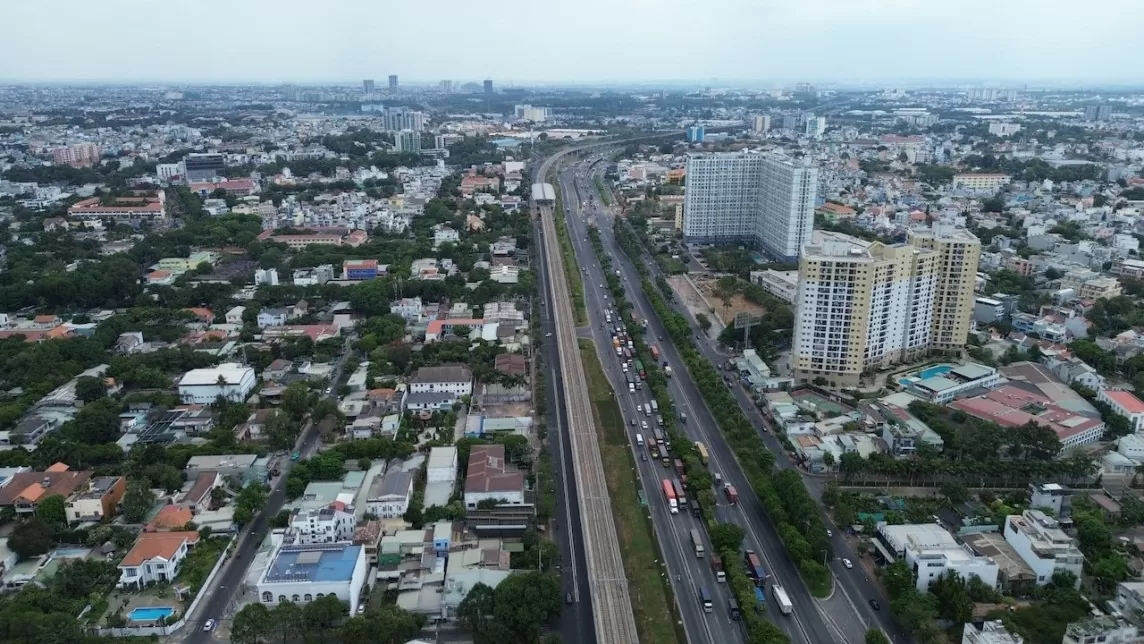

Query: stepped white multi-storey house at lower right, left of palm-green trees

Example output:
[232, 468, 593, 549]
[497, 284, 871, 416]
[1002, 510, 1085, 586]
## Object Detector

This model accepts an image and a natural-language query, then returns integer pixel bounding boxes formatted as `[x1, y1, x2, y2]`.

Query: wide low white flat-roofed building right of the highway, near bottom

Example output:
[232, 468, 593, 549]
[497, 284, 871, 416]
[877, 522, 999, 593]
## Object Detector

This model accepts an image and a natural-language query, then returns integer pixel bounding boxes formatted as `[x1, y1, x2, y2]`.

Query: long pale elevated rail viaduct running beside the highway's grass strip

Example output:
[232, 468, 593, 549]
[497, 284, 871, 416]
[534, 151, 638, 644]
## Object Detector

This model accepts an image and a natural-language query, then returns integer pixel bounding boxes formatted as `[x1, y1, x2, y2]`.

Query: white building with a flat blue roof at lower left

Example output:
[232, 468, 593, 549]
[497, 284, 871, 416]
[255, 543, 370, 610]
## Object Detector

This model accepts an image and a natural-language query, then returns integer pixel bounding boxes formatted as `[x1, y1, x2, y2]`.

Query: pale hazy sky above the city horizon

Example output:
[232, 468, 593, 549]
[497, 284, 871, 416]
[0, 0, 1144, 86]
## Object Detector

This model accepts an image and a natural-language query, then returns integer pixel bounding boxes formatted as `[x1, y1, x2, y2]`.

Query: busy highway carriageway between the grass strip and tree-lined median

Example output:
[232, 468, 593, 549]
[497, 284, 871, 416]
[559, 166, 742, 643]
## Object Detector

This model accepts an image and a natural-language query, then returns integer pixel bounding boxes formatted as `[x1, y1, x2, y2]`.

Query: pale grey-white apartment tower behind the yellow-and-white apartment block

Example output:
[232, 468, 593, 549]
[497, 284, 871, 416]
[683, 152, 818, 262]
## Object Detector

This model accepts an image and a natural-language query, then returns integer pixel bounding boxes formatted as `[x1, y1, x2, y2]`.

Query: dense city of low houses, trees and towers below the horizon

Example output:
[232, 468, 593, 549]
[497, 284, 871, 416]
[0, 26, 1144, 644]
